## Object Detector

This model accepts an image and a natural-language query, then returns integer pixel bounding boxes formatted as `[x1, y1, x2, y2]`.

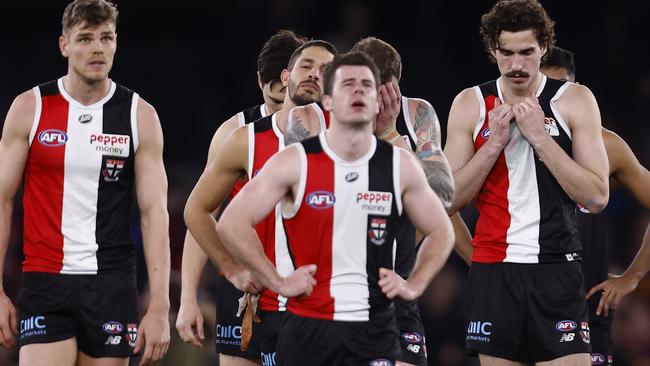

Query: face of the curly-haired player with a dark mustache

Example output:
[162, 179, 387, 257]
[492, 30, 546, 90]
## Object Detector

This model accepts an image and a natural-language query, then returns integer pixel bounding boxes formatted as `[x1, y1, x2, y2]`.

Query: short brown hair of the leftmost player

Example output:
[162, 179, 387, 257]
[61, 0, 119, 35]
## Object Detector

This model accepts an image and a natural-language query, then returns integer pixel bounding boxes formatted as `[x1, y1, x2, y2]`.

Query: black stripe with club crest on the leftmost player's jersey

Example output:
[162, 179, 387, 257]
[95, 85, 135, 270]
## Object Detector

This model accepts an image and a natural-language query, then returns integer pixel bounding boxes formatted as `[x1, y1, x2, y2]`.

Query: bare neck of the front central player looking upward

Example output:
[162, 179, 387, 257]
[325, 119, 373, 161]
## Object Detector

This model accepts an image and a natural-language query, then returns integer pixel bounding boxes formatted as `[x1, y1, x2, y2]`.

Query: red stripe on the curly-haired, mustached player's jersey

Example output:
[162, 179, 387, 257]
[472, 95, 511, 263]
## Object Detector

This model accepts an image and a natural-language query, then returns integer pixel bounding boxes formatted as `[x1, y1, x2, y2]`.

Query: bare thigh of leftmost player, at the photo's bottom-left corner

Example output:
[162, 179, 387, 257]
[18, 338, 77, 366]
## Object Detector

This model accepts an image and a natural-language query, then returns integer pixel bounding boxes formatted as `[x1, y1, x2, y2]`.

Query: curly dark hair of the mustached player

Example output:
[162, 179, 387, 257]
[480, 0, 555, 62]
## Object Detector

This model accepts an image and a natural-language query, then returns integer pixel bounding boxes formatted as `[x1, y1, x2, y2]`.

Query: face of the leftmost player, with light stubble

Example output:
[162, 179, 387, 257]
[59, 22, 117, 83]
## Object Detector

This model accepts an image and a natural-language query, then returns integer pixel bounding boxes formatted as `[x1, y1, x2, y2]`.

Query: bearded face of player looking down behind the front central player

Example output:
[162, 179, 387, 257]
[288, 46, 334, 105]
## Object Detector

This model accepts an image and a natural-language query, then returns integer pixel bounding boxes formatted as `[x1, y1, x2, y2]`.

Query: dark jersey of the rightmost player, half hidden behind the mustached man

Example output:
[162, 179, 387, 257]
[578, 206, 609, 291]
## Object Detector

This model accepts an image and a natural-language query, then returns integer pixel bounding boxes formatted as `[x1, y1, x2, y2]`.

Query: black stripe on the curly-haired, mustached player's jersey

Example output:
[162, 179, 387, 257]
[535, 78, 582, 262]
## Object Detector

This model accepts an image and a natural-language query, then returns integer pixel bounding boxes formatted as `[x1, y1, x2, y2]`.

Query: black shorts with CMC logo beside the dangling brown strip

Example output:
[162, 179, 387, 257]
[214, 275, 260, 361]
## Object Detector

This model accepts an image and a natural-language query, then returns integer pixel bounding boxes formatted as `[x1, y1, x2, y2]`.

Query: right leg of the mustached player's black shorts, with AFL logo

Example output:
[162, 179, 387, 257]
[526, 262, 591, 362]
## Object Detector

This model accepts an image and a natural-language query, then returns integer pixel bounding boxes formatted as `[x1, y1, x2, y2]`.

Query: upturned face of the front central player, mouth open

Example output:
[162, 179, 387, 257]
[323, 65, 379, 124]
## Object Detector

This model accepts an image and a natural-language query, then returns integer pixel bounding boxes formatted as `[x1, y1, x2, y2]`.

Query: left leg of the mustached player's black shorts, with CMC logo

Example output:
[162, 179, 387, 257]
[465, 263, 527, 362]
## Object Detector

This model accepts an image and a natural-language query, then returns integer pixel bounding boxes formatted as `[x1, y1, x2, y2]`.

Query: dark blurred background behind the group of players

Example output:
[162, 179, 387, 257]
[0, 0, 650, 365]
